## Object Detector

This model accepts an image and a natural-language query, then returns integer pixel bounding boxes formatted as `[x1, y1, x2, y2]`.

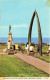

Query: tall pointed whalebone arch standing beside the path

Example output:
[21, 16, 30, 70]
[28, 10, 42, 55]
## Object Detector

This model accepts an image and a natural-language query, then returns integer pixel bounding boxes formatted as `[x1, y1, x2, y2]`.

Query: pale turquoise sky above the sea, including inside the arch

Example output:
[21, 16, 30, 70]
[0, 0, 50, 38]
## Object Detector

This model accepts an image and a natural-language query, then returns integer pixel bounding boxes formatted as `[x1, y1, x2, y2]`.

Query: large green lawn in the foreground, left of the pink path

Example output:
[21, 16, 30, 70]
[0, 54, 49, 77]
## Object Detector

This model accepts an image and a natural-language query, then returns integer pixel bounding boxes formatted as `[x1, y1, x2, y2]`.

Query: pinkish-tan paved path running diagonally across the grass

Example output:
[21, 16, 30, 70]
[16, 54, 50, 74]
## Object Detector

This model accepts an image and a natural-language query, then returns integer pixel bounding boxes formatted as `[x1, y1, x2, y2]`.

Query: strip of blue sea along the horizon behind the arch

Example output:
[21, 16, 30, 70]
[0, 37, 50, 44]
